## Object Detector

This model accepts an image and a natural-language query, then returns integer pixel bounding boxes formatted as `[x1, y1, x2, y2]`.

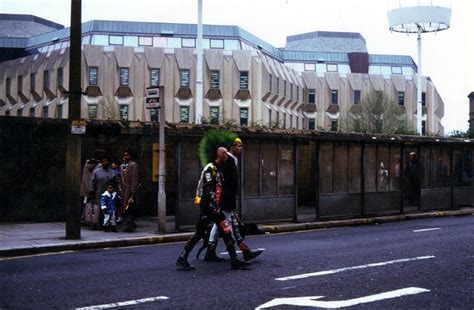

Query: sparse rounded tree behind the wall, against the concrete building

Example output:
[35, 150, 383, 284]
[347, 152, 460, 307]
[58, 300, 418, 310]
[339, 92, 416, 134]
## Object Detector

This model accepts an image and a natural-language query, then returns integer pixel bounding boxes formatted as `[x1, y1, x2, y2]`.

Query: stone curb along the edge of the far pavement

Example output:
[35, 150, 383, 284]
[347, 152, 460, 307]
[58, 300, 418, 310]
[0, 208, 474, 258]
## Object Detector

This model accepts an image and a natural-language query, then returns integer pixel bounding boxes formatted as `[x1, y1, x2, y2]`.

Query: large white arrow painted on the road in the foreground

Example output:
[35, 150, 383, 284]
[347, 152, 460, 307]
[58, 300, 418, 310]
[256, 287, 430, 310]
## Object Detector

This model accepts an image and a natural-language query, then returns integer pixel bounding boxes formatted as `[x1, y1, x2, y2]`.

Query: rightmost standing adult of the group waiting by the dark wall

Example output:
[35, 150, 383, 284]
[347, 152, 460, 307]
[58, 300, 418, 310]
[119, 149, 140, 232]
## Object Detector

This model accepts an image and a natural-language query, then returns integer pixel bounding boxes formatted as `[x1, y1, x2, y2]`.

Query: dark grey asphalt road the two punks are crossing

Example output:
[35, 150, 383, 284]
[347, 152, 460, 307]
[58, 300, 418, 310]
[0, 216, 474, 309]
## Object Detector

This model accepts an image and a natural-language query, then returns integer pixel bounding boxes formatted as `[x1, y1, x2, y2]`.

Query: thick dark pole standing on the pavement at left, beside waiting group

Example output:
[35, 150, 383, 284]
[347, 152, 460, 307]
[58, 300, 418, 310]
[66, 0, 82, 239]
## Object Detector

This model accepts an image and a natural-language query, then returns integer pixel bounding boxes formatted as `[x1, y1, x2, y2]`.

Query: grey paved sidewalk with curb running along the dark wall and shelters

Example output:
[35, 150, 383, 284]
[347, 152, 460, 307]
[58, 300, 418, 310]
[0, 208, 474, 258]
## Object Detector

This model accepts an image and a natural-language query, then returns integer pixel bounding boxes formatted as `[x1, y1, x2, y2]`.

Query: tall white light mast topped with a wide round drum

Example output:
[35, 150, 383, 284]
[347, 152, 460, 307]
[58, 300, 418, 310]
[388, 0, 451, 135]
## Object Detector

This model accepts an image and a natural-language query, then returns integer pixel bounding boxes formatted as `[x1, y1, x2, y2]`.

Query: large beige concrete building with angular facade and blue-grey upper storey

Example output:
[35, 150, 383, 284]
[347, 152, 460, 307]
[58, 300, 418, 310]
[0, 14, 444, 134]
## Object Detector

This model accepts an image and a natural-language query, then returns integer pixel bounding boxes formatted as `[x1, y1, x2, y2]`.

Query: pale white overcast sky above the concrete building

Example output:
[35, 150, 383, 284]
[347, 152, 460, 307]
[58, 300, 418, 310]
[0, 0, 474, 133]
